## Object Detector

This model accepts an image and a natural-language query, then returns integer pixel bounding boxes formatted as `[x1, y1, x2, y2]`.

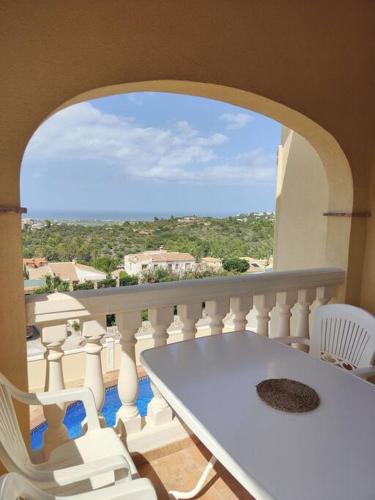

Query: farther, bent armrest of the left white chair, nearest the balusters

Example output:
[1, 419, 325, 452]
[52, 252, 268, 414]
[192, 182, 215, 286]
[36, 387, 100, 431]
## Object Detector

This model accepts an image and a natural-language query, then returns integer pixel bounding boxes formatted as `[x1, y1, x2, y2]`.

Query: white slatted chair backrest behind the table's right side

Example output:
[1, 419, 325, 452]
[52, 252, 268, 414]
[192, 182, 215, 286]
[310, 304, 375, 370]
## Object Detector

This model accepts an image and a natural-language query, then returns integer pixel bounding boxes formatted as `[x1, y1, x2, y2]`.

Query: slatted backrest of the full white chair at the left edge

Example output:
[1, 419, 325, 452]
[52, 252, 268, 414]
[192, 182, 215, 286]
[0, 374, 32, 472]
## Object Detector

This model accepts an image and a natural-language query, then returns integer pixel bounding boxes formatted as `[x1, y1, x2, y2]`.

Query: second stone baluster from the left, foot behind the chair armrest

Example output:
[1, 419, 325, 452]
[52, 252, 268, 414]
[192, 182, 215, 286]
[82, 315, 107, 426]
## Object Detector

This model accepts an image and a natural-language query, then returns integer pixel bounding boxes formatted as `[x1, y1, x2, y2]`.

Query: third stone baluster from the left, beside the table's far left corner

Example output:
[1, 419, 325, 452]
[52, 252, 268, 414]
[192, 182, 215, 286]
[116, 311, 142, 439]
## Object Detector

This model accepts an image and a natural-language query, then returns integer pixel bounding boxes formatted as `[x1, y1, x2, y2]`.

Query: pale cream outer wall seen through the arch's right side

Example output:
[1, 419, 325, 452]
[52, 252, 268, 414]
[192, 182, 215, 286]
[274, 127, 328, 271]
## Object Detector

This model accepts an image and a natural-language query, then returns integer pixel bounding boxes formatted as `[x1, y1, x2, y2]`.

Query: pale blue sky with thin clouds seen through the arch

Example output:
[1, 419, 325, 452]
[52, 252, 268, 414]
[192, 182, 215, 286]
[21, 92, 281, 215]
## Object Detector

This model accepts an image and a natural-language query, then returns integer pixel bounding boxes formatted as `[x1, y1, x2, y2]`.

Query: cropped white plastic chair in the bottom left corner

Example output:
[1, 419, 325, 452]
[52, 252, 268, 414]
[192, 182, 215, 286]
[0, 472, 157, 500]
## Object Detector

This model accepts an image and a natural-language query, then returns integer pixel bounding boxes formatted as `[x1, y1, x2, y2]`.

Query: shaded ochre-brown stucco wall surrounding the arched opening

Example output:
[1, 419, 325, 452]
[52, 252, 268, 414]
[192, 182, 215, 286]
[0, 0, 375, 458]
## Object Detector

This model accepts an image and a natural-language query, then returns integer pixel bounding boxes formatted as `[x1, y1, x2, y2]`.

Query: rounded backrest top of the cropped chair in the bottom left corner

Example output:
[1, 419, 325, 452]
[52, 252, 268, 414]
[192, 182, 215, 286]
[0, 472, 56, 500]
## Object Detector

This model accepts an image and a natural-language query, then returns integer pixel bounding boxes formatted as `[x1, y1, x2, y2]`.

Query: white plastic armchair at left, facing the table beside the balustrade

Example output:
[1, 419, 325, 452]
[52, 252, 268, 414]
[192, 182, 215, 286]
[0, 374, 153, 498]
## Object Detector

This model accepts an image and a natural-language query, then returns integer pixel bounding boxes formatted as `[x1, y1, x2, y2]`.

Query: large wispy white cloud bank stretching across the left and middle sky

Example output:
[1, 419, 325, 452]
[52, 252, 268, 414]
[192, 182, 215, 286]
[25, 103, 275, 184]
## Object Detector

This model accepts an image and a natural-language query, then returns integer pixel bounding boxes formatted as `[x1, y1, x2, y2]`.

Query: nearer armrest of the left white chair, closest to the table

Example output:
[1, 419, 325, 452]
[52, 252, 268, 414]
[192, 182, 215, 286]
[53, 455, 130, 486]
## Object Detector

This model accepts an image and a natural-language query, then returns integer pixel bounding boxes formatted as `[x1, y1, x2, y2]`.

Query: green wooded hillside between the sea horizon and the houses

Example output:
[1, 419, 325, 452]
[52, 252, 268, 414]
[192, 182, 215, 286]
[22, 214, 274, 266]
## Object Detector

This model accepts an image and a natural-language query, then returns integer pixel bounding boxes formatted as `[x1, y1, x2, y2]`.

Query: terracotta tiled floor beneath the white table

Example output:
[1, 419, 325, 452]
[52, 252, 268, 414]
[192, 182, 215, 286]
[136, 439, 253, 500]
